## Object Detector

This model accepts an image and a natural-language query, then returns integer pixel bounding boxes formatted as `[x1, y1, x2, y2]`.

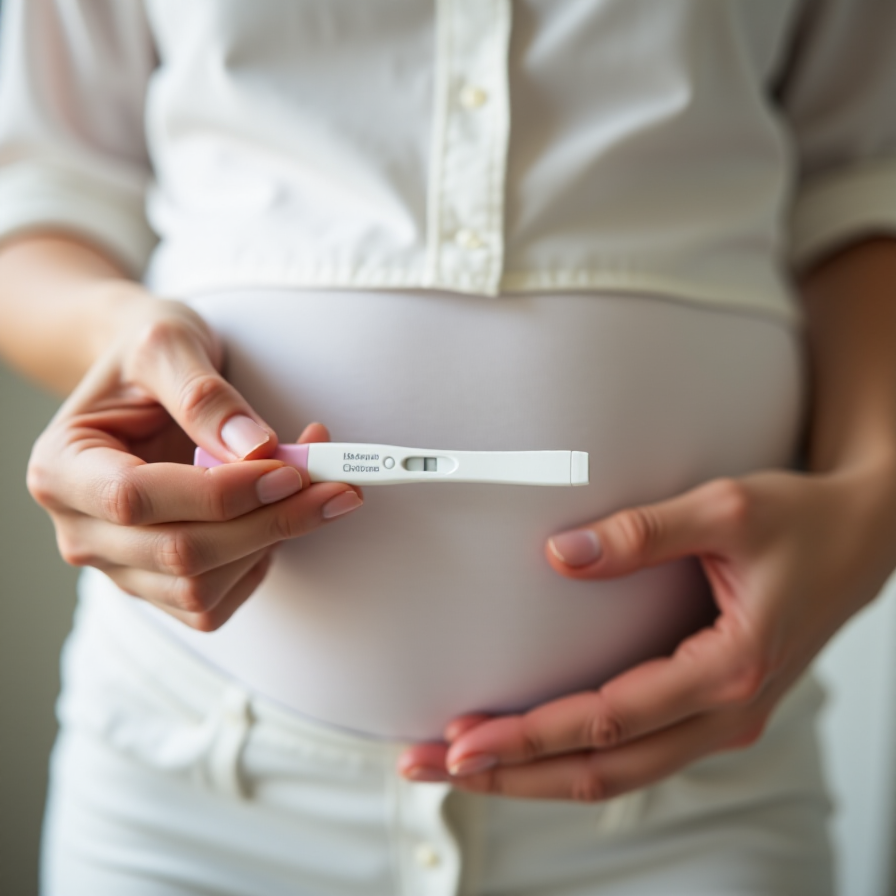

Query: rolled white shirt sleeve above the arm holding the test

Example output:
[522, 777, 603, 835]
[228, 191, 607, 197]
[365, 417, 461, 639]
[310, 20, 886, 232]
[0, 0, 156, 276]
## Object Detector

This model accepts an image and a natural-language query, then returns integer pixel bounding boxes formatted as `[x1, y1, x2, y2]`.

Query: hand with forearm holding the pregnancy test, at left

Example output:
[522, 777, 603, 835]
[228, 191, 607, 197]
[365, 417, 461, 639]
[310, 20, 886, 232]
[0, 234, 362, 631]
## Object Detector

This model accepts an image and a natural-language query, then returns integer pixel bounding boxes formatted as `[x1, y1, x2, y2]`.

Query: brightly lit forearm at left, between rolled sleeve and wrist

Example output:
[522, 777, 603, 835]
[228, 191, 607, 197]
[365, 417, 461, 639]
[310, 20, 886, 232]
[0, 233, 147, 394]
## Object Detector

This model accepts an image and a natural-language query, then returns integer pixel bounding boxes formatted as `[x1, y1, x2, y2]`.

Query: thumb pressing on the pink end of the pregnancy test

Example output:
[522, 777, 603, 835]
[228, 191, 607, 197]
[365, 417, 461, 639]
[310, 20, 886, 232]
[125, 312, 277, 461]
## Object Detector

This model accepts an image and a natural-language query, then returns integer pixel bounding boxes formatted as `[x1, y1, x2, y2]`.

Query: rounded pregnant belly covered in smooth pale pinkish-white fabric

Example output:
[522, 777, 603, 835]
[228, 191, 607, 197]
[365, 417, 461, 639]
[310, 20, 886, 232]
[144, 290, 802, 739]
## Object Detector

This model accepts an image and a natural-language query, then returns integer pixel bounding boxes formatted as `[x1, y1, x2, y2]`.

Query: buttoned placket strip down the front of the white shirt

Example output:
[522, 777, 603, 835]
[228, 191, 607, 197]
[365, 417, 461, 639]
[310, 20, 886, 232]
[426, 0, 511, 295]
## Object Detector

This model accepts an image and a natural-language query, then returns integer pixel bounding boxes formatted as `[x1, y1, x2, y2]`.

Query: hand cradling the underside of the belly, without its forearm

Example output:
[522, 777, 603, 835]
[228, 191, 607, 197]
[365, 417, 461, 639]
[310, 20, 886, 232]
[399, 465, 896, 801]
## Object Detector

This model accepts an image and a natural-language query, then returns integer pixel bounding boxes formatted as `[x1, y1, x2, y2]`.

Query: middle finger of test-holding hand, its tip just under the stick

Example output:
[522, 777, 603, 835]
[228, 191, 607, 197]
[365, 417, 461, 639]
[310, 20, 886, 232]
[60, 482, 363, 578]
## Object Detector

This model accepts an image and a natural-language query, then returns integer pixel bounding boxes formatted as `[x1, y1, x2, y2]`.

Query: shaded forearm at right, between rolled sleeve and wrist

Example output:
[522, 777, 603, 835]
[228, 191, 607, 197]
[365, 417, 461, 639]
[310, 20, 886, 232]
[803, 239, 896, 593]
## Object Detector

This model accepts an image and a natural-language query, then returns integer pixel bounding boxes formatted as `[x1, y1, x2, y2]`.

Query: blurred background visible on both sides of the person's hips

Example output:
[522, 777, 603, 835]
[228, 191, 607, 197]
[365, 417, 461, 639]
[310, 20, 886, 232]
[0, 0, 896, 896]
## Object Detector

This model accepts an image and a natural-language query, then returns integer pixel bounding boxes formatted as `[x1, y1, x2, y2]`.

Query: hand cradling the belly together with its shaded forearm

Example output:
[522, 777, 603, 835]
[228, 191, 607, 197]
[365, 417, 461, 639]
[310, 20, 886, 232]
[399, 239, 896, 801]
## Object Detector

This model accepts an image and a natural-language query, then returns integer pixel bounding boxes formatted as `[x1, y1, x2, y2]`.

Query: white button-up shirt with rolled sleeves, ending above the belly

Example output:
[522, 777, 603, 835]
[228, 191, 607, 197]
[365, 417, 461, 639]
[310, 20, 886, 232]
[0, 0, 896, 316]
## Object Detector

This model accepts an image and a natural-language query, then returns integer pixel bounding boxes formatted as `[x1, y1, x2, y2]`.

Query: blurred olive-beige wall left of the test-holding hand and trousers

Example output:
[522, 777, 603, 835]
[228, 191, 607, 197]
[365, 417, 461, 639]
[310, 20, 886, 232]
[0, 364, 76, 896]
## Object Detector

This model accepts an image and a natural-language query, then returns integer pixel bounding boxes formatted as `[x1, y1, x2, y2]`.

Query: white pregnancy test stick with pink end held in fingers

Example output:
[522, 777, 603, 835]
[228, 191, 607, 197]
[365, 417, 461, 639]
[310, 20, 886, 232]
[194, 442, 588, 485]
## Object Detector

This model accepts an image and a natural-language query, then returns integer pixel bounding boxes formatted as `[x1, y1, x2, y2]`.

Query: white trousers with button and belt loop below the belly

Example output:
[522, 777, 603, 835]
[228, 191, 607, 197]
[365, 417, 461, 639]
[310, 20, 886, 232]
[42, 595, 832, 896]
